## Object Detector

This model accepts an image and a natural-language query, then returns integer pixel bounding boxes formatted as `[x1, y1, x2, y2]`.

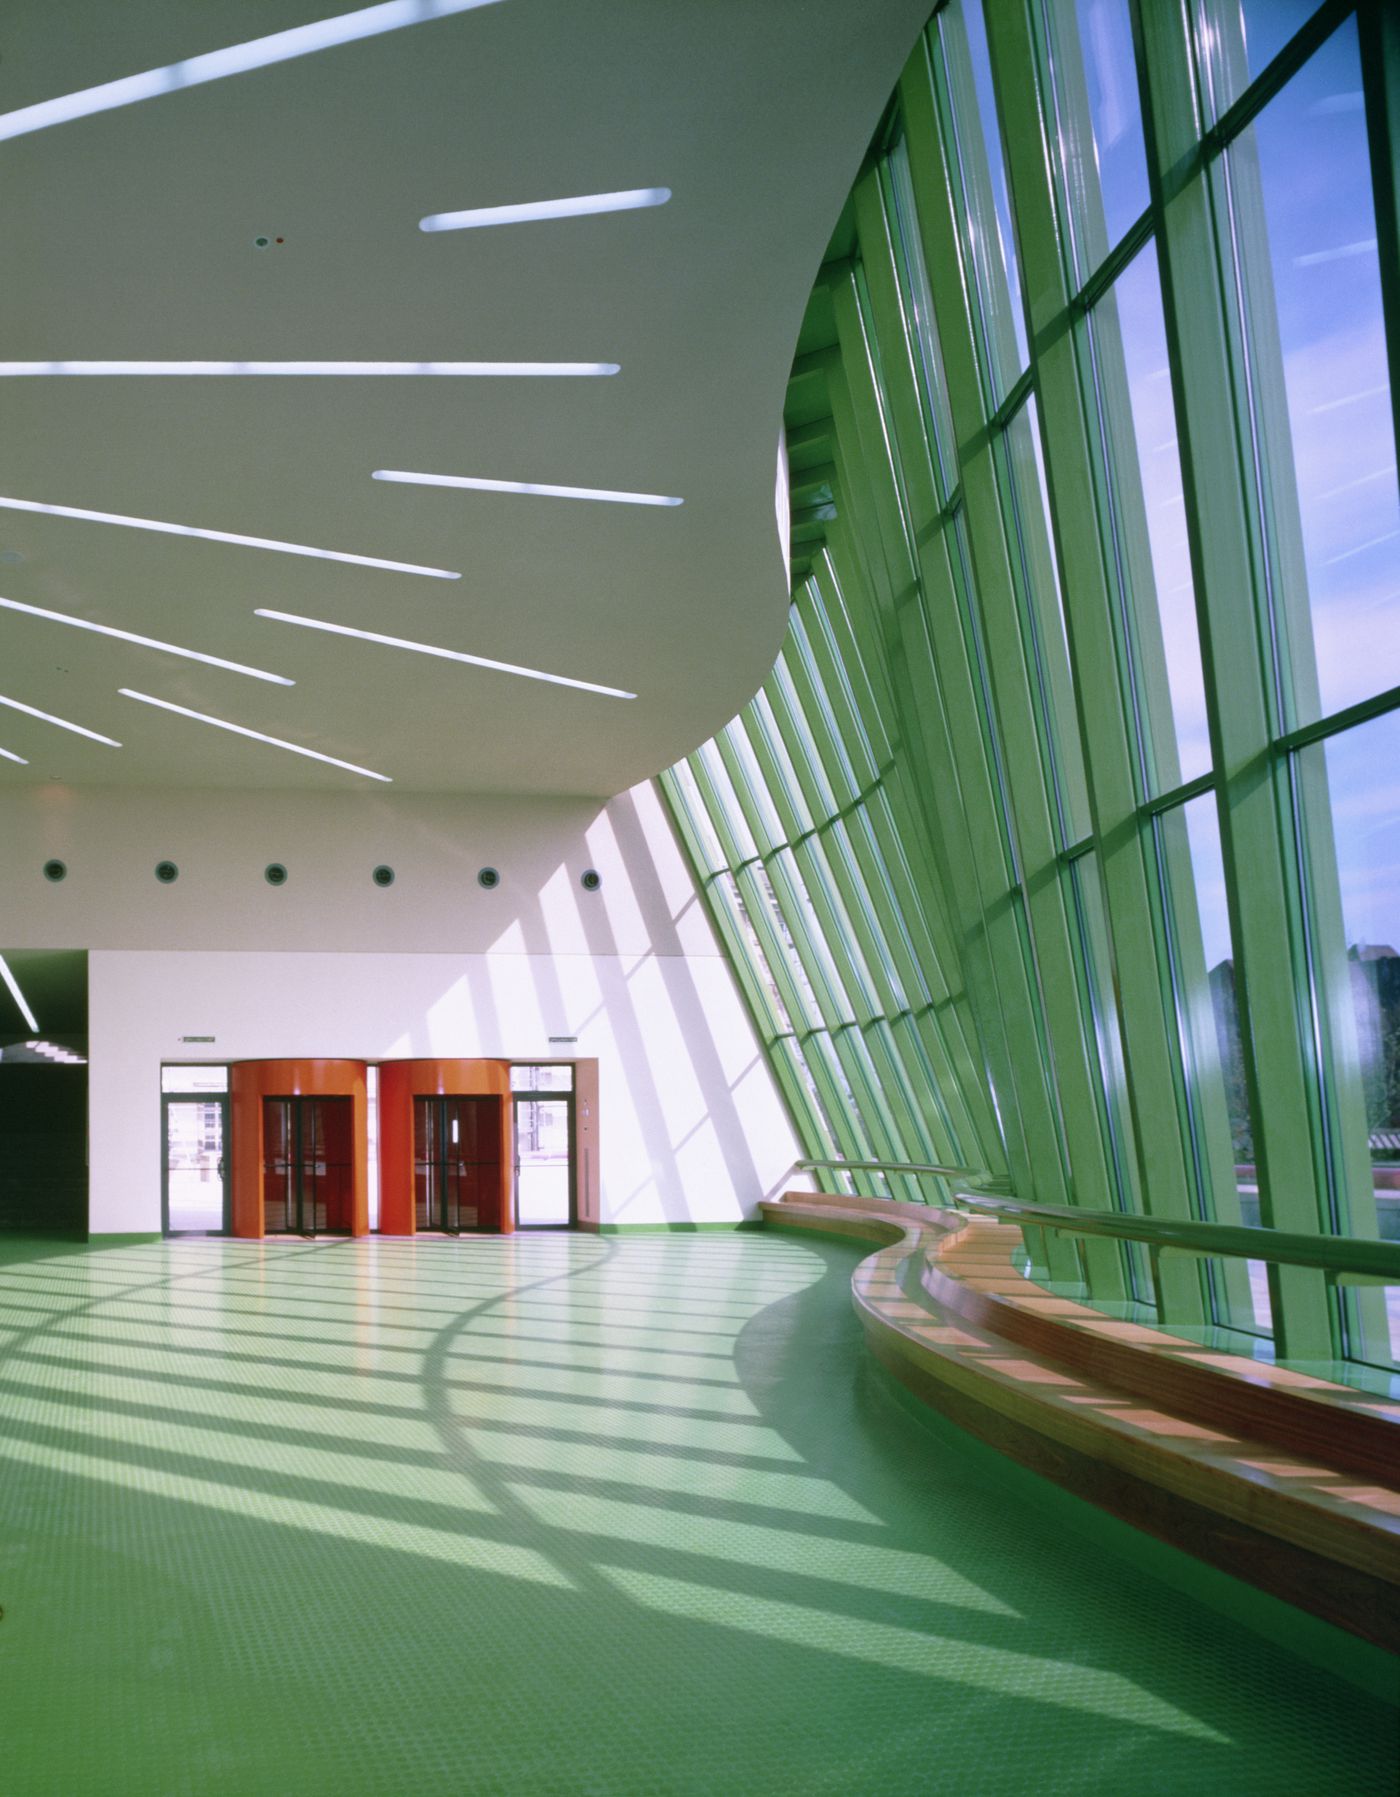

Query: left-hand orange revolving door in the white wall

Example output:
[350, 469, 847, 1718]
[228, 1060, 370, 1236]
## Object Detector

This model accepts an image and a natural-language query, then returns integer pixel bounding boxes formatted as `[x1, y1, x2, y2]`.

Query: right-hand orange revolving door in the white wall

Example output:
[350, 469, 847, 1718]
[379, 1060, 514, 1235]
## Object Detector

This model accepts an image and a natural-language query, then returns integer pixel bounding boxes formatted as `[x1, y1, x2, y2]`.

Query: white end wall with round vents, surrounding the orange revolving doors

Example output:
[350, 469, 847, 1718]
[0, 785, 800, 1233]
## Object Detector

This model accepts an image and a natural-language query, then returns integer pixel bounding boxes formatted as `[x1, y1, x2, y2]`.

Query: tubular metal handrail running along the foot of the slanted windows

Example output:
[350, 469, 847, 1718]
[796, 1161, 1400, 1285]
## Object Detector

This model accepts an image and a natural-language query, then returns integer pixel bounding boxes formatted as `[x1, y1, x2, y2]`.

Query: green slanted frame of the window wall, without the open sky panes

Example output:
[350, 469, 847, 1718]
[660, 0, 1400, 1366]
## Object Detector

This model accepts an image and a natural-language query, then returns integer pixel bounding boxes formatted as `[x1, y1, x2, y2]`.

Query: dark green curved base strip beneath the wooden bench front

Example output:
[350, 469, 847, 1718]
[868, 1357, 1400, 1705]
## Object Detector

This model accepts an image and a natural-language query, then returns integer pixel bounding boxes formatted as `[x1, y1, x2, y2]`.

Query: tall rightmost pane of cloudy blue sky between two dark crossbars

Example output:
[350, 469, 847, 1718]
[1231, 22, 1400, 722]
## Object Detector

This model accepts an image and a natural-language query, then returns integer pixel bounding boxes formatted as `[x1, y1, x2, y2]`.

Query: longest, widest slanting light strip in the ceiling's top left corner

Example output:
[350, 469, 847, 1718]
[0, 0, 510, 138]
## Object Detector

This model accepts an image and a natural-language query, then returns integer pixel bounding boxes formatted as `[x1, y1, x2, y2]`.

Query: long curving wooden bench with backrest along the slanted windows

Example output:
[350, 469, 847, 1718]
[762, 1191, 1400, 1651]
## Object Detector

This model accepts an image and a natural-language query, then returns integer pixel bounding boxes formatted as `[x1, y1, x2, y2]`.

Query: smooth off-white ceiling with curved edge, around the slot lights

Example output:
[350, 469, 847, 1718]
[0, 0, 927, 796]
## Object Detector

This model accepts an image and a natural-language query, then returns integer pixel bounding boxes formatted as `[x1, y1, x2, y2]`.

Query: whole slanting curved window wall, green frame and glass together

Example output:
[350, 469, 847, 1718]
[661, 0, 1400, 1368]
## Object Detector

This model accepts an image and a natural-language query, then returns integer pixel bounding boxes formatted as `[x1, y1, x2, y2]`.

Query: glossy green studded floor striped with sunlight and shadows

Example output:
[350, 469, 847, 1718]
[0, 1235, 1396, 1797]
